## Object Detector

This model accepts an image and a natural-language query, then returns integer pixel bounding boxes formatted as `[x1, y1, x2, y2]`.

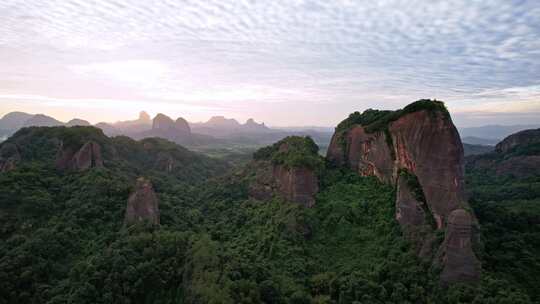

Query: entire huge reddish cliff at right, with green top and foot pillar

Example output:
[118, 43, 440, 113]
[327, 100, 479, 281]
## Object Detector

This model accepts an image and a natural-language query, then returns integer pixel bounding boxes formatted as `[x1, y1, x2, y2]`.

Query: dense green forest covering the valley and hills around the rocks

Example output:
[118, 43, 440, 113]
[0, 128, 540, 303]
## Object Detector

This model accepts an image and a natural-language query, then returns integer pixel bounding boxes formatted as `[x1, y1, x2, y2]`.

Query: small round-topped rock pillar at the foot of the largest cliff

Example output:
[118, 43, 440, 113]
[441, 209, 480, 283]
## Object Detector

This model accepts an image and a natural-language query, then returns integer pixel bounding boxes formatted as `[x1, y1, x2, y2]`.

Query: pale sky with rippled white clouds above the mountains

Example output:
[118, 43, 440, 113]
[0, 0, 540, 127]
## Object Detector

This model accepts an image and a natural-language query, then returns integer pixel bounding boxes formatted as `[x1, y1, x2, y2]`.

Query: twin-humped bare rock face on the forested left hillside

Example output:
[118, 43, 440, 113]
[56, 141, 103, 171]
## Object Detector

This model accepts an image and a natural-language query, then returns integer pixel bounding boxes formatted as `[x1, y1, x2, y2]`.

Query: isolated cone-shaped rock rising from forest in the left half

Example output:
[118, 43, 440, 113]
[125, 177, 159, 225]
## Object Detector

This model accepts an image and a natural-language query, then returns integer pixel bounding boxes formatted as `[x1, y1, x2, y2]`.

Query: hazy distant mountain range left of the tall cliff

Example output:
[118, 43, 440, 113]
[0, 111, 332, 149]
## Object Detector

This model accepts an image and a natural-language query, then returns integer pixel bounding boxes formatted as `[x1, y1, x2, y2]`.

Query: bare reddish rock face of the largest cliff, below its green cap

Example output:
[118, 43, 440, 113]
[327, 110, 465, 228]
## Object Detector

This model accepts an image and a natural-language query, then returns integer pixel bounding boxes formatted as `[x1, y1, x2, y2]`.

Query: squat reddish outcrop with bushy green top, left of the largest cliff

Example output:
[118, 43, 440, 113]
[249, 136, 322, 207]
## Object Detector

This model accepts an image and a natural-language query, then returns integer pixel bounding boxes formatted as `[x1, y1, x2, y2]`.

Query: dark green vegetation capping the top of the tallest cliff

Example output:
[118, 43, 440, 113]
[336, 99, 450, 133]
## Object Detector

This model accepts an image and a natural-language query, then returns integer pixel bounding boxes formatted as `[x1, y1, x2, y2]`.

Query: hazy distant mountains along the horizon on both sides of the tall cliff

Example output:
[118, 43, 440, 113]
[4, 111, 540, 155]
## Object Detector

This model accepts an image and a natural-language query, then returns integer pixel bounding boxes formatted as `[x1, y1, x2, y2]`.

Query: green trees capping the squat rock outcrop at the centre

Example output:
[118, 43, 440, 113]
[253, 136, 324, 170]
